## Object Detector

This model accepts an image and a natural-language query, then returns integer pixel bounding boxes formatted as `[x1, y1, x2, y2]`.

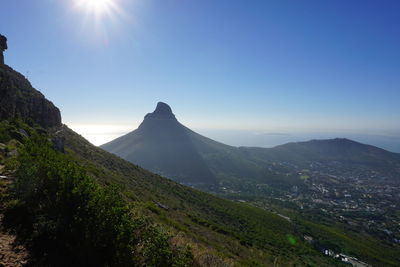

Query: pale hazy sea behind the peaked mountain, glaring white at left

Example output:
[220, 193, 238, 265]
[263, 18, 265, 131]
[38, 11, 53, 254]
[67, 118, 400, 153]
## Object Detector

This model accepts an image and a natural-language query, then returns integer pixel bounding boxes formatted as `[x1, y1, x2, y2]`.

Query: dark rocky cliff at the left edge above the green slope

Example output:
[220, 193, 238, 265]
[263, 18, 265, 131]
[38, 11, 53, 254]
[0, 35, 61, 128]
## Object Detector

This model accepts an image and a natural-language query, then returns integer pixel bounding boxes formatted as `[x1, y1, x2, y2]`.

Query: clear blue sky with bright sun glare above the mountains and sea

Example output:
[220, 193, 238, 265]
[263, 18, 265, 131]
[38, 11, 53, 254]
[0, 0, 400, 149]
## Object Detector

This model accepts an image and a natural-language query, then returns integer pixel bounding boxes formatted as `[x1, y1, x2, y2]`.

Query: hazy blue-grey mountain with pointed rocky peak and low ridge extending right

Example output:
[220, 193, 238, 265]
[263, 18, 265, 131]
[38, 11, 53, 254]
[101, 102, 400, 187]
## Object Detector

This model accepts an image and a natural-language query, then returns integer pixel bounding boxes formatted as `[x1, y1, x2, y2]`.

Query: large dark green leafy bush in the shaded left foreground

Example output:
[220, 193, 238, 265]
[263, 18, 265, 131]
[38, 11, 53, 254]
[5, 141, 192, 266]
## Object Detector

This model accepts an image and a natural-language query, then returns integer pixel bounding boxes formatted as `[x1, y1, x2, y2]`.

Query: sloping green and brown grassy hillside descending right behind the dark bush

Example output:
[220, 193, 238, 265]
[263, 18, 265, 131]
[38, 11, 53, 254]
[56, 124, 344, 266]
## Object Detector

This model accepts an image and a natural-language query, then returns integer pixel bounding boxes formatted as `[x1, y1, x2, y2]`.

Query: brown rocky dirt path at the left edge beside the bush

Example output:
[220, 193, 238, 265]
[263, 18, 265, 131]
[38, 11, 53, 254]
[0, 176, 28, 267]
